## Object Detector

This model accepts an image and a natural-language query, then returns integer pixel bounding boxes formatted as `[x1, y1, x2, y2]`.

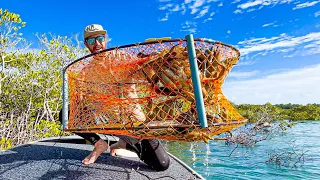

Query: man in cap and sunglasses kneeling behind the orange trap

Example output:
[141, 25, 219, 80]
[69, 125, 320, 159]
[60, 24, 170, 171]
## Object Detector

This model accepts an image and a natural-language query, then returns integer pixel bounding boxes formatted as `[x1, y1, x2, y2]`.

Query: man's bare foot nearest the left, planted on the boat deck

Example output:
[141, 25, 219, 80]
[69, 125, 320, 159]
[82, 139, 109, 165]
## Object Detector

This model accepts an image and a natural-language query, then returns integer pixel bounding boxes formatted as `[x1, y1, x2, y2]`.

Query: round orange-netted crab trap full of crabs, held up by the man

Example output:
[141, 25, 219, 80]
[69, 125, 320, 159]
[63, 35, 247, 142]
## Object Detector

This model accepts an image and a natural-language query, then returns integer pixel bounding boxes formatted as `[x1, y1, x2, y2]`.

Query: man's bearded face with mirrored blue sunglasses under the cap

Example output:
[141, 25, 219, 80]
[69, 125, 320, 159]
[84, 34, 106, 53]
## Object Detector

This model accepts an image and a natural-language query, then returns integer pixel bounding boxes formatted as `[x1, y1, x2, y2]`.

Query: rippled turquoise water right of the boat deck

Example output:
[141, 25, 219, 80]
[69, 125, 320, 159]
[168, 121, 320, 180]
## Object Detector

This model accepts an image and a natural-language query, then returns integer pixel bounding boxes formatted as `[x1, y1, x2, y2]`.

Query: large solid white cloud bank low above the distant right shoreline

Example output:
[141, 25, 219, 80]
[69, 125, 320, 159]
[222, 64, 320, 104]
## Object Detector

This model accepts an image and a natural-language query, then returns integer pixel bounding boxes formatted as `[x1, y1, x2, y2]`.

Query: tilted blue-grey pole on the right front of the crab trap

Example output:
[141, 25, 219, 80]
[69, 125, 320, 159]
[185, 34, 208, 128]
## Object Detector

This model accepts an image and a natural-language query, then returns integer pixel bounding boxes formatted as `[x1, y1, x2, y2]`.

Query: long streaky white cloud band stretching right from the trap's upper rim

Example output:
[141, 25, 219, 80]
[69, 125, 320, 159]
[238, 32, 320, 55]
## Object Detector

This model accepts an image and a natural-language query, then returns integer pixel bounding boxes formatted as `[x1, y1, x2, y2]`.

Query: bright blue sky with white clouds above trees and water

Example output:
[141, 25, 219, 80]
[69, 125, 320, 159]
[0, 0, 320, 104]
